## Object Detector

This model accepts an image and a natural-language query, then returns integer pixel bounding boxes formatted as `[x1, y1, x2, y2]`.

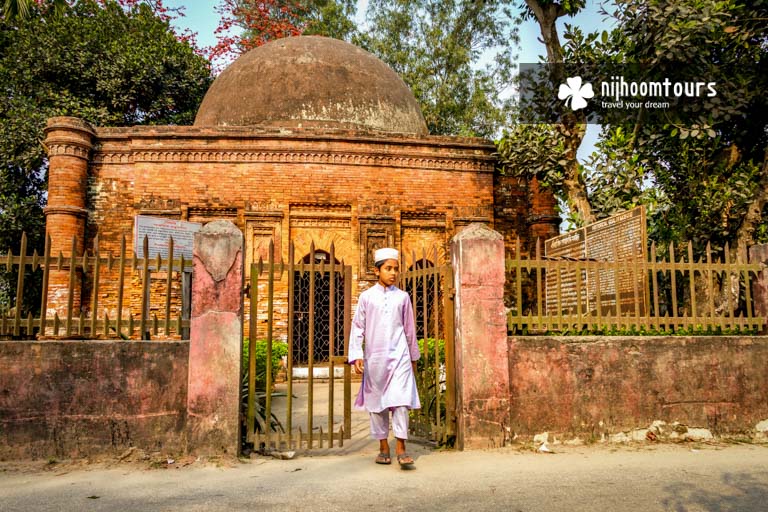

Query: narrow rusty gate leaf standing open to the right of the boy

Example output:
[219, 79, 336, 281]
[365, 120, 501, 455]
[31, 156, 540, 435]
[400, 251, 456, 444]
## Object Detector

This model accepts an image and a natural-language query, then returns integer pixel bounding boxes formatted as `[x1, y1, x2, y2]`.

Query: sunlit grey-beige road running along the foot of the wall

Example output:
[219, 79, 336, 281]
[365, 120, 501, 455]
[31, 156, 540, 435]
[0, 442, 768, 512]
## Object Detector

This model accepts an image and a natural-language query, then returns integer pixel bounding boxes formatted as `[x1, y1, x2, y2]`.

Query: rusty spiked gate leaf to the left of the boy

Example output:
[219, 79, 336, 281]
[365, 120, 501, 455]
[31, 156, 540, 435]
[243, 242, 352, 450]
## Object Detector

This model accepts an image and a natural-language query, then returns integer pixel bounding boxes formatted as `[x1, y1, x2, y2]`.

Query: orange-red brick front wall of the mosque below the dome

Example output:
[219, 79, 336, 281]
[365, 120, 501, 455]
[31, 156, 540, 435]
[46, 118, 553, 344]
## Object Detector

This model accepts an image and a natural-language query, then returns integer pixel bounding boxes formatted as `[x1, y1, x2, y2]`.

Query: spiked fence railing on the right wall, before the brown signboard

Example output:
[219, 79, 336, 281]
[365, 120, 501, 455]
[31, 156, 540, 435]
[506, 240, 766, 334]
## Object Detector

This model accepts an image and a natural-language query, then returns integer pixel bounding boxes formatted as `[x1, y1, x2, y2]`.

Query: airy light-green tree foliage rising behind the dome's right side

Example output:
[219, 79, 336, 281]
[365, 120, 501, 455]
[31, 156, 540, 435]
[354, 0, 517, 137]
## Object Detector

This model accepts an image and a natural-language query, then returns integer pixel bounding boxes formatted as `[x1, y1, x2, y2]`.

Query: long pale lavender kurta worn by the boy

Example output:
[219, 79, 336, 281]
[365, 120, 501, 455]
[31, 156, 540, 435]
[349, 283, 421, 412]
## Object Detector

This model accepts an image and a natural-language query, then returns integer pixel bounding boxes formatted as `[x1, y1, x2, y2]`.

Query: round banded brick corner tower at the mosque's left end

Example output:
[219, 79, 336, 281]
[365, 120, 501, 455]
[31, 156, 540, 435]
[44, 117, 95, 316]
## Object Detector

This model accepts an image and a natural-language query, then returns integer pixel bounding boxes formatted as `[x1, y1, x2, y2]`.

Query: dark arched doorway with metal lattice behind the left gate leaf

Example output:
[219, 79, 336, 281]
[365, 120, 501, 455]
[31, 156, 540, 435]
[292, 249, 346, 365]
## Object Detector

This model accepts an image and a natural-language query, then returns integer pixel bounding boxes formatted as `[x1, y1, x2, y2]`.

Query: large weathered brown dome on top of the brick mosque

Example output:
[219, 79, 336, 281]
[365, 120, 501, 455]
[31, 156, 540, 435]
[195, 36, 428, 135]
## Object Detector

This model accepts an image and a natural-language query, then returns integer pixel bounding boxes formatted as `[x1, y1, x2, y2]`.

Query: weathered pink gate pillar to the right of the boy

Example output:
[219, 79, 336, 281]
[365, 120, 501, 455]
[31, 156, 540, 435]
[451, 223, 509, 450]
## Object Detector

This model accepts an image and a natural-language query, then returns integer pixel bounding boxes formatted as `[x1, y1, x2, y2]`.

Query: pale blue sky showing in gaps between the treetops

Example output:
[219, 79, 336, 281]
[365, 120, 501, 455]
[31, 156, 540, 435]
[164, 0, 608, 162]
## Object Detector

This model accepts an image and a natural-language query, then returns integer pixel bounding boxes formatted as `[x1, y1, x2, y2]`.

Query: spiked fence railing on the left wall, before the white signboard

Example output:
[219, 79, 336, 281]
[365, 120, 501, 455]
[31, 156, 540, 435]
[0, 234, 192, 339]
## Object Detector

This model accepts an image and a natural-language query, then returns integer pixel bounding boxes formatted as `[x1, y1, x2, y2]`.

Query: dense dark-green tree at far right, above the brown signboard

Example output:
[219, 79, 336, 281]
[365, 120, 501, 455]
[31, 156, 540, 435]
[574, 0, 768, 252]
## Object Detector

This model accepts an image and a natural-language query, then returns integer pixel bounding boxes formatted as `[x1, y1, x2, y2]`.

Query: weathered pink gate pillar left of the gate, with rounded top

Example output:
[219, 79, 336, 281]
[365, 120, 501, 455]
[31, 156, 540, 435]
[187, 221, 243, 455]
